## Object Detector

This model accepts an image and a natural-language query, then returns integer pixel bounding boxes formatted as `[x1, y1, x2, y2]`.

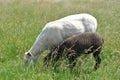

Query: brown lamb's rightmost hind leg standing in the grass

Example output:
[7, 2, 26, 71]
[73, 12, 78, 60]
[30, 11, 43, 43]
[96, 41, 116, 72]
[93, 49, 101, 70]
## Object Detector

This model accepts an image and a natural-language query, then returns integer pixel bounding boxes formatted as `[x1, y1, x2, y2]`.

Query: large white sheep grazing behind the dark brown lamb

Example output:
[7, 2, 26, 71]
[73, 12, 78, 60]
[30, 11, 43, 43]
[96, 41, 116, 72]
[24, 13, 97, 65]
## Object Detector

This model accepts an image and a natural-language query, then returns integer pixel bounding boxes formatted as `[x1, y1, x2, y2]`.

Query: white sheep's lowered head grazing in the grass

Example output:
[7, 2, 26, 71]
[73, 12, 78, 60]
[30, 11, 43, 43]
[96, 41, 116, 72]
[24, 52, 36, 66]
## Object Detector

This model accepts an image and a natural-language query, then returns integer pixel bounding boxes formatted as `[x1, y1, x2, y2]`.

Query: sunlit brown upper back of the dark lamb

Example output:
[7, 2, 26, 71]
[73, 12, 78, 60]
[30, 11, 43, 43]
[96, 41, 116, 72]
[64, 32, 103, 46]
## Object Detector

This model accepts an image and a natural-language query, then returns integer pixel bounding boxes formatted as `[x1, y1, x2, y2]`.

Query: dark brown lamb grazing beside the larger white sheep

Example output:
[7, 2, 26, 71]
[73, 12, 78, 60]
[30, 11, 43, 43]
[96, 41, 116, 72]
[45, 32, 104, 70]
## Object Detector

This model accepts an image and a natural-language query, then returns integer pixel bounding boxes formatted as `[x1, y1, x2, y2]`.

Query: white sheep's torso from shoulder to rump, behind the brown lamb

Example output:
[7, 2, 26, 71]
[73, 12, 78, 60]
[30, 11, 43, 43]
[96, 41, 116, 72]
[41, 14, 97, 49]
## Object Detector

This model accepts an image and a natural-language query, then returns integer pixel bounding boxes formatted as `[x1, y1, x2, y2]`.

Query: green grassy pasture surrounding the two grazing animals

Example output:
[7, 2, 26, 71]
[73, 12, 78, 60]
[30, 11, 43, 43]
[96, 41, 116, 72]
[0, 0, 120, 80]
